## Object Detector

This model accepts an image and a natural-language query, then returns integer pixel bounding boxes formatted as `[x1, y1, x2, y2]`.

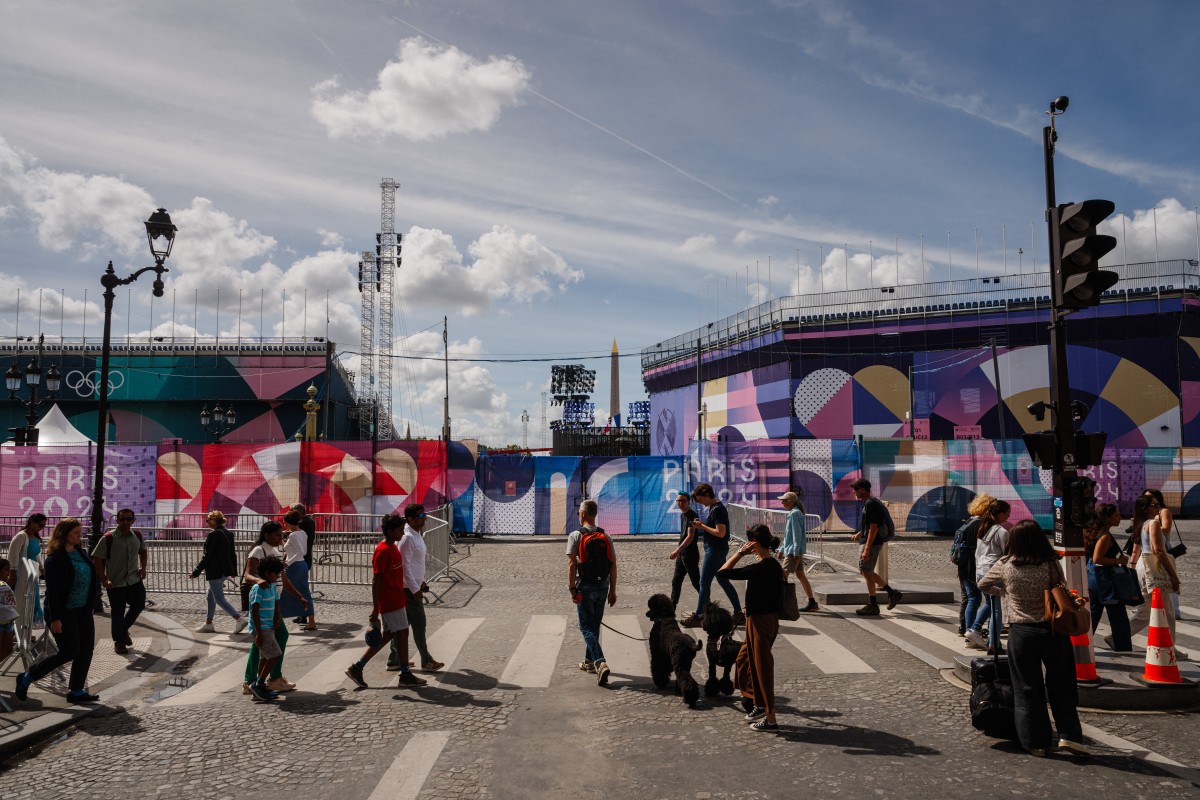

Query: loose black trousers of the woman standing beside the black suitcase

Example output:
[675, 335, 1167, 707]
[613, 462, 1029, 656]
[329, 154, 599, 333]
[1008, 622, 1084, 750]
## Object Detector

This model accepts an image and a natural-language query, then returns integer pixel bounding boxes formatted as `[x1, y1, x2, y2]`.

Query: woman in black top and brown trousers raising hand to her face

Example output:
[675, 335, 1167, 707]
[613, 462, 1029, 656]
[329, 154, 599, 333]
[720, 525, 786, 732]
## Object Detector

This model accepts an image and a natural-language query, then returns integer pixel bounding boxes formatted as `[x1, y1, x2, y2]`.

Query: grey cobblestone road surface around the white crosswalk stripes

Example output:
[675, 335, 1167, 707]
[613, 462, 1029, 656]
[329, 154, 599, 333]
[0, 531, 1200, 800]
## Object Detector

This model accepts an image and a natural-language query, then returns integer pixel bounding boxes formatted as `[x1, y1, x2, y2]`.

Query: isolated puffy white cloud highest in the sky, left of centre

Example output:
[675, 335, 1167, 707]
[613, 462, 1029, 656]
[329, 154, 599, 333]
[312, 36, 530, 142]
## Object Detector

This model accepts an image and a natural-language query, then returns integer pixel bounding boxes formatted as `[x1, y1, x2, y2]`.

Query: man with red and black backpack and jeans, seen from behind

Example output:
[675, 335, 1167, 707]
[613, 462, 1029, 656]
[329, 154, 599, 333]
[566, 500, 617, 686]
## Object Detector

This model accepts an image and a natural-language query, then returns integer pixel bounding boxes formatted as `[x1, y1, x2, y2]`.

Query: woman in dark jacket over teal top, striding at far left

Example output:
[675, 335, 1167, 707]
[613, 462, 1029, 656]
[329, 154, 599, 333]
[16, 517, 100, 703]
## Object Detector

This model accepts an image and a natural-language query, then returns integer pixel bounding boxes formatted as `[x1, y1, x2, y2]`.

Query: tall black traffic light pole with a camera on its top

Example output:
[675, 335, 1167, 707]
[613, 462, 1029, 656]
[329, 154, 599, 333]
[1025, 97, 1118, 597]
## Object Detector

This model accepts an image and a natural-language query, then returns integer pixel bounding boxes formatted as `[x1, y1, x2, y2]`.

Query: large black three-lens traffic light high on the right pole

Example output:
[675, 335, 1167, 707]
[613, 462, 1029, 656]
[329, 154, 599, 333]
[1050, 200, 1118, 308]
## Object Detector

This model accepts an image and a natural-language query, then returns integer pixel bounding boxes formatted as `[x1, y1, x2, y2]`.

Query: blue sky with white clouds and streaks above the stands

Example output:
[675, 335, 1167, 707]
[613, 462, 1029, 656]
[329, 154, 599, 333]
[0, 0, 1200, 447]
